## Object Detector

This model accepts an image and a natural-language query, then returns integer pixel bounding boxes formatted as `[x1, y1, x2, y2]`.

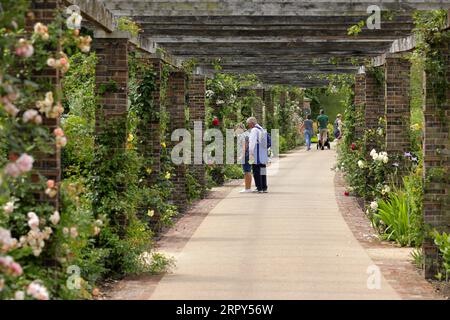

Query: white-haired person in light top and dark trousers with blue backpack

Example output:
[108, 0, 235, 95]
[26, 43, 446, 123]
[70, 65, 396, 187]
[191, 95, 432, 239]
[247, 117, 269, 193]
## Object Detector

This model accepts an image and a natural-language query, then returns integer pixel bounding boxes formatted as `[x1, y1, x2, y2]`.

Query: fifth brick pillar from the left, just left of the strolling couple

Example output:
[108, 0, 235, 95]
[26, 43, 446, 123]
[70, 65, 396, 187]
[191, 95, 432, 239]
[188, 75, 206, 196]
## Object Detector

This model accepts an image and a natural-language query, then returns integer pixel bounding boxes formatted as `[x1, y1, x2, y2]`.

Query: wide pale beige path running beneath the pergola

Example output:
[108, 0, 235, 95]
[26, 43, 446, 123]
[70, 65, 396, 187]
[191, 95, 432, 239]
[106, 146, 436, 299]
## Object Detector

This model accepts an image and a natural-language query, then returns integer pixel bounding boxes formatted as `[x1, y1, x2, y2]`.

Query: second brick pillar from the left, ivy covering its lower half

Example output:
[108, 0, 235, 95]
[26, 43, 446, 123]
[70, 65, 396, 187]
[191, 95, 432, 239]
[94, 34, 129, 230]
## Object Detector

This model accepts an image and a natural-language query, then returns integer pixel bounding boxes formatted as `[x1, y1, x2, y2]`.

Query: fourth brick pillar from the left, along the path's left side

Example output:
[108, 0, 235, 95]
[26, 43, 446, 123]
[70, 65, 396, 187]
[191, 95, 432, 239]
[167, 71, 187, 212]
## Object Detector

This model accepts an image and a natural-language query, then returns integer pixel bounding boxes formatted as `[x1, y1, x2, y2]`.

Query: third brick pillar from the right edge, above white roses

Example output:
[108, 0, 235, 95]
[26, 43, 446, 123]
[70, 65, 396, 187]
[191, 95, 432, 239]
[364, 70, 385, 152]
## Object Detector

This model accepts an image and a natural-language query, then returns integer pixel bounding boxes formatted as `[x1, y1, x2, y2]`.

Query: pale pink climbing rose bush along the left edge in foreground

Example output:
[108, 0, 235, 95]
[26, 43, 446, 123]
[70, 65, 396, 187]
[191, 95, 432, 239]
[0, 0, 92, 300]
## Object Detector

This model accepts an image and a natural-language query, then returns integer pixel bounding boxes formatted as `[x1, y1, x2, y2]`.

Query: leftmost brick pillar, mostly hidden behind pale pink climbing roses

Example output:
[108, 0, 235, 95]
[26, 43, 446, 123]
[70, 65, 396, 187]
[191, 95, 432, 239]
[25, 0, 61, 208]
